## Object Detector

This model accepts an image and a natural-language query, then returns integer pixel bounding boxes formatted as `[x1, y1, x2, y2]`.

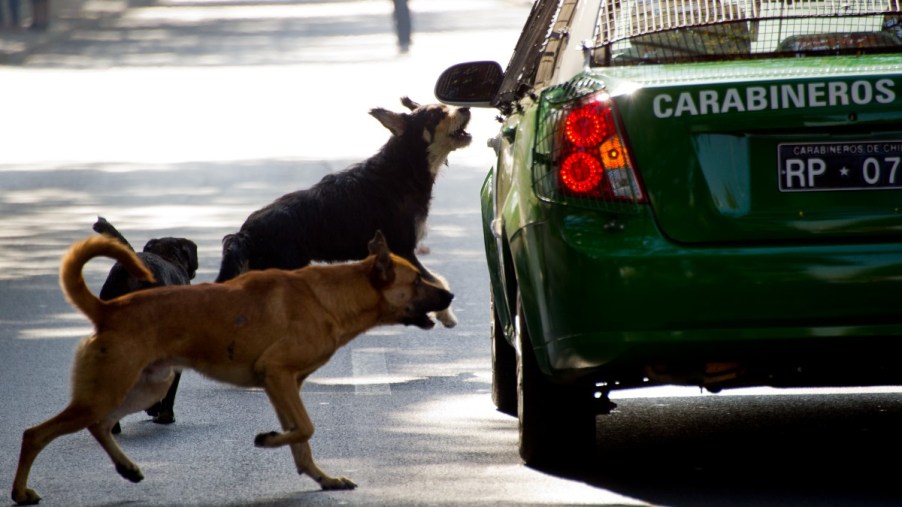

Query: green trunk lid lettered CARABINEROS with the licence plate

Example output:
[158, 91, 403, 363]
[595, 55, 902, 243]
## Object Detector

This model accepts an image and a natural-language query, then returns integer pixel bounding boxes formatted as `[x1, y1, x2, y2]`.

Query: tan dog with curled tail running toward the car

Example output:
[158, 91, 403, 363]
[12, 232, 453, 504]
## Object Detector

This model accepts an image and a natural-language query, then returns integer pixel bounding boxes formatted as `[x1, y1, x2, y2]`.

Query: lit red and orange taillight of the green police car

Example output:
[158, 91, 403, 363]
[557, 95, 645, 203]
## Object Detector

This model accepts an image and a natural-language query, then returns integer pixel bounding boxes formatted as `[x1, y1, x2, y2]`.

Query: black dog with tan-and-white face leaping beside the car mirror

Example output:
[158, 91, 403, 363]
[216, 97, 471, 327]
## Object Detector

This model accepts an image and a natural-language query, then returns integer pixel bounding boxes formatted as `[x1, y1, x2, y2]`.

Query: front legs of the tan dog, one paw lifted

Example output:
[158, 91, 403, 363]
[254, 372, 357, 490]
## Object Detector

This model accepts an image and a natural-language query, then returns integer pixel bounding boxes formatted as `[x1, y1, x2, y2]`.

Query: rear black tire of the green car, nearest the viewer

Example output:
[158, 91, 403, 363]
[516, 298, 596, 465]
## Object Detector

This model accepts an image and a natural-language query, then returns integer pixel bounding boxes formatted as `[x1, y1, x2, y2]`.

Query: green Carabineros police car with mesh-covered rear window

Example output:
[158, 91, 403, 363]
[436, 0, 902, 463]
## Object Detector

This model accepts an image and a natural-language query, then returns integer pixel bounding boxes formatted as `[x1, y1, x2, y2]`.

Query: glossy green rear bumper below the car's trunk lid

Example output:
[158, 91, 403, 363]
[510, 209, 902, 385]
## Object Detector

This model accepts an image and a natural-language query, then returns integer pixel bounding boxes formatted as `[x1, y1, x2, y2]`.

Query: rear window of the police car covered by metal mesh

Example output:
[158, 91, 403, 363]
[592, 0, 902, 66]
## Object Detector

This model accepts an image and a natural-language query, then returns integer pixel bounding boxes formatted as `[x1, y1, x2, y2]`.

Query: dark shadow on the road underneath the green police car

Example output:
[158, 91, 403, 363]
[538, 394, 902, 506]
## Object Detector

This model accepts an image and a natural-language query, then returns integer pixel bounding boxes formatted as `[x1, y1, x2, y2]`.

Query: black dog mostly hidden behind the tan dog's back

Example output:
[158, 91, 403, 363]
[94, 217, 198, 433]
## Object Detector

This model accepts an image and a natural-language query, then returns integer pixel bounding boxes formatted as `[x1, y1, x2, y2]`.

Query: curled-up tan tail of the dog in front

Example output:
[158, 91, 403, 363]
[60, 235, 154, 324]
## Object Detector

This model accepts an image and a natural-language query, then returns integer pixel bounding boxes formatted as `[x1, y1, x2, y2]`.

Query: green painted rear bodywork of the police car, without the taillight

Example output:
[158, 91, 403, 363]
[481, 55, 902, 384]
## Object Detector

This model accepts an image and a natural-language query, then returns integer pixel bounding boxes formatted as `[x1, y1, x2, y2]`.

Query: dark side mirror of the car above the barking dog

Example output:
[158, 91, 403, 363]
[435, 61, 504, 107]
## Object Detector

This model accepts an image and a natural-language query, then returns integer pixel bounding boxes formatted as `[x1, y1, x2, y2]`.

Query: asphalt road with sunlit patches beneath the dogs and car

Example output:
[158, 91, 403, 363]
[0, 0, 902, 506]
